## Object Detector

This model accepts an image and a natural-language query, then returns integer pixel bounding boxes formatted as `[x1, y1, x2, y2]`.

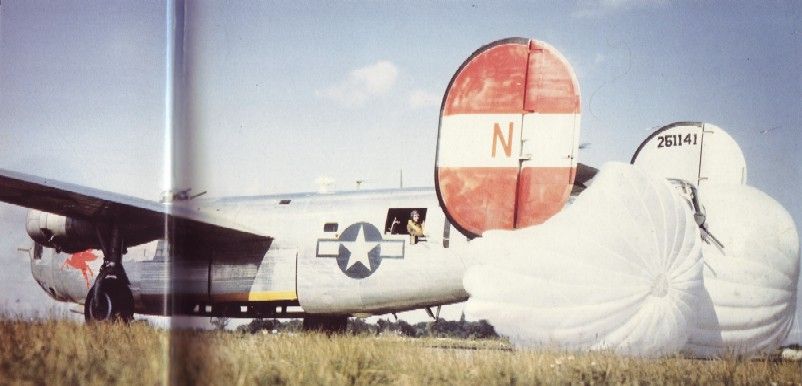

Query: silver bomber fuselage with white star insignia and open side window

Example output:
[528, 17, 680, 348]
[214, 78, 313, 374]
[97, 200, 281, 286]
[31, 189, 467, 317]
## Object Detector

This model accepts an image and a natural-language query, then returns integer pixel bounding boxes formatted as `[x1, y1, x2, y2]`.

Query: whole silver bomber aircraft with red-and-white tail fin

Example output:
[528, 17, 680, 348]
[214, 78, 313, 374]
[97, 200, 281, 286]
[0, 34, 745, 331]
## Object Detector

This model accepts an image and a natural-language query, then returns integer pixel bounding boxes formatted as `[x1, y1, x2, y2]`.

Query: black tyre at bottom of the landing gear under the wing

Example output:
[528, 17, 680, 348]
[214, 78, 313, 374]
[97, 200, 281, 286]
[84, 277, 134, 323]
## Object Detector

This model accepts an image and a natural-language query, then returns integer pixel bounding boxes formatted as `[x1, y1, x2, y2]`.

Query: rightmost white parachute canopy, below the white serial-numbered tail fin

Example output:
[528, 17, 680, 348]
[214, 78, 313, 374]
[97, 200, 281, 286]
[685, 184, 799, 357]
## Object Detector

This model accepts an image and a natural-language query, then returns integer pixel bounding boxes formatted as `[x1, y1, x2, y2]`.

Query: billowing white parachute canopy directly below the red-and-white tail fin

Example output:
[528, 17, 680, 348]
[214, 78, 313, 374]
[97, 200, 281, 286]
[463, 163, 702, 356]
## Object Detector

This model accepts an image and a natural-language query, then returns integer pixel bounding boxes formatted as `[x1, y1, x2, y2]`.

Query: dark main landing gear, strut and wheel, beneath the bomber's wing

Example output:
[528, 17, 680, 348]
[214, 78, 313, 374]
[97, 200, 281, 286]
[84, 225, 134, 323]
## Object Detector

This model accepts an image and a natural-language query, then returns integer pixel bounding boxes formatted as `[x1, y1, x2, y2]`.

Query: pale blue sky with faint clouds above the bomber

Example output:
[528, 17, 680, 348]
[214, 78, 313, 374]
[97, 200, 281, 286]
[0, 0, 802, 338]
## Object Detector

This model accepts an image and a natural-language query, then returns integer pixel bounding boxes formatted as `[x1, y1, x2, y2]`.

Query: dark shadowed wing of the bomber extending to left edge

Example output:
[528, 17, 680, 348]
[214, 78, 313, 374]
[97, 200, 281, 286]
[0, 169, 270, 245]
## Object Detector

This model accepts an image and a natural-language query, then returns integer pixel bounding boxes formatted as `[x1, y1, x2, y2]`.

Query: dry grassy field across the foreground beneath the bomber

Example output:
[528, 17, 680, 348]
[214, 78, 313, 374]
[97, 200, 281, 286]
[0, 321, 802, 385]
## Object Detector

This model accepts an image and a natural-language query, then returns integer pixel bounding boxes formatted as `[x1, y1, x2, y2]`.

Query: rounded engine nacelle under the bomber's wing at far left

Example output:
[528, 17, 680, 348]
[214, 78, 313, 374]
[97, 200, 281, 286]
[25, 209, 100, 253]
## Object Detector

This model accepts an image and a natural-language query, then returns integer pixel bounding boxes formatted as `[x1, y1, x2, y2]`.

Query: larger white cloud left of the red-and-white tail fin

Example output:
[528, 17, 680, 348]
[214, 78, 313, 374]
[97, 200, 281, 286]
[315, 60, 398, 107]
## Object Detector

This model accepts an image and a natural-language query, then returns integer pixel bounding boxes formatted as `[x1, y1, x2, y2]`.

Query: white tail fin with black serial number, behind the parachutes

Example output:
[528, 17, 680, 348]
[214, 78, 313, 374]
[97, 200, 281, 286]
[631, 122, 746, 186]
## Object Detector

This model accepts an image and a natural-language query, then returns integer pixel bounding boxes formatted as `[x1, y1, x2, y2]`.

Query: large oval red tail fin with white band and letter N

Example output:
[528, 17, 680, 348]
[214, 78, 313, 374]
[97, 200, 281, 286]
[435, 38, 580, 236]
